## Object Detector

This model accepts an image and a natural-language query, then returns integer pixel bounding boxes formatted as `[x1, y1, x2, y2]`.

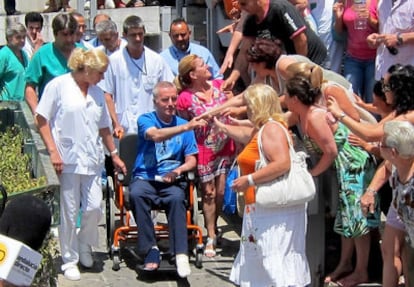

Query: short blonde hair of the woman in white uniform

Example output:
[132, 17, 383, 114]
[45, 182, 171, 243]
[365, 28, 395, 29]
[68, 48, 109, 72]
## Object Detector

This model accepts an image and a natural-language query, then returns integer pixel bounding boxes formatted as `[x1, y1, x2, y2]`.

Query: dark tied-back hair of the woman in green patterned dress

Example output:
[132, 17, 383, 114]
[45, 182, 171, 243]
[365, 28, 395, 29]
[286, 76, 321, 106]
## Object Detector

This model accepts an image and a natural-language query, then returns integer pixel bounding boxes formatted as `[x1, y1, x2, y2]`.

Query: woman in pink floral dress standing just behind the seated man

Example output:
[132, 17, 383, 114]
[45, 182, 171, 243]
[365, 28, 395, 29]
[175, 55, 235, 257]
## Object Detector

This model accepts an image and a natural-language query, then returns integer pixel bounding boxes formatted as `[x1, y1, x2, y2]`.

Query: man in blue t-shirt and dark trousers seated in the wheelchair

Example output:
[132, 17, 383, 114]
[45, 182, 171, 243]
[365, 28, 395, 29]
[130, 82, 206, 278]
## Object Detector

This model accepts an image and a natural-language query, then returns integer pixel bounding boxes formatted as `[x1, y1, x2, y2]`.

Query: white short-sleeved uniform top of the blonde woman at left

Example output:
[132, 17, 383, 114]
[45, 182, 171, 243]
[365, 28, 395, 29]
[36, 73, 111, 175]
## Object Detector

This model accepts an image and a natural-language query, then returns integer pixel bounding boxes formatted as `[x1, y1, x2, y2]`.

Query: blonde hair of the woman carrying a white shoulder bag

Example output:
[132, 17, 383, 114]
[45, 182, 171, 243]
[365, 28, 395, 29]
[243, 84, 286, 128]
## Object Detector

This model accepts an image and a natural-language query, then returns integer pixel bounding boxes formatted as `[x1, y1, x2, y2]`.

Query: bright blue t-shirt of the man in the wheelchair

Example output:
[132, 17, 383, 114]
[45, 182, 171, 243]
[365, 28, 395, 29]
[132, 112, 198, 180]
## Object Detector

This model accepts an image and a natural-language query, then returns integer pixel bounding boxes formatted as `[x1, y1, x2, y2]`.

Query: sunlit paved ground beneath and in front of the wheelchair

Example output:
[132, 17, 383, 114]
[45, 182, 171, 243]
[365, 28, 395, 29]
[58, 213, 241, 287]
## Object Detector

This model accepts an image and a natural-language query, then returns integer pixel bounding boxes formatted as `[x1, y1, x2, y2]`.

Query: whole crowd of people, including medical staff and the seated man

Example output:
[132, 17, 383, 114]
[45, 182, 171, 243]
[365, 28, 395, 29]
[0, 0, 414, 287]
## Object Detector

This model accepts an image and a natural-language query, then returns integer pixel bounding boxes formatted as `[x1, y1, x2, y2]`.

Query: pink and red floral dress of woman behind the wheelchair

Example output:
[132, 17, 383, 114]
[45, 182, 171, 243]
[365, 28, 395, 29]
[177, 80, 235, 182]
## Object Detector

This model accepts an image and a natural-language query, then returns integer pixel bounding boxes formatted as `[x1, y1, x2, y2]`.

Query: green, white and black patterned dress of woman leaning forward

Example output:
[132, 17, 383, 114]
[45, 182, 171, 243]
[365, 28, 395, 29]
[304, 123, 380, 238]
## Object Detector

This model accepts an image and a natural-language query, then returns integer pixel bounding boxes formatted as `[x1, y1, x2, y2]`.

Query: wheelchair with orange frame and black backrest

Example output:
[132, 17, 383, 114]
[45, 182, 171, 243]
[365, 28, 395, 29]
[105, 134, 204, 271]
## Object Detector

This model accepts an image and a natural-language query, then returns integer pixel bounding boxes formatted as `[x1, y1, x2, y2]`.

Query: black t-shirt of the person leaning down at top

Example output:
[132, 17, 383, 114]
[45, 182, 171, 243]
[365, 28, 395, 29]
[243, 0, 327, 64]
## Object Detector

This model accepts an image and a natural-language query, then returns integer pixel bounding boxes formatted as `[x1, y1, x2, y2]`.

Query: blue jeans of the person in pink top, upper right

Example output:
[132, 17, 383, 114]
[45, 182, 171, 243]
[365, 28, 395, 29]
[344, 55, 375, 103]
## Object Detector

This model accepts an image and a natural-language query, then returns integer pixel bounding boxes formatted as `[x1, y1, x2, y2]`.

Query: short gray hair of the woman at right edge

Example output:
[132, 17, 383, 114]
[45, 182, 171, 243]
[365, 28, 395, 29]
[384, 120, 414, 158]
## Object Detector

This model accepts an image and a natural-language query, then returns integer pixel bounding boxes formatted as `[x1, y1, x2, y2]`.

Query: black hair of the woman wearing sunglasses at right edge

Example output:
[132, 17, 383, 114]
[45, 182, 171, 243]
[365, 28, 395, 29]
[388, 65, 414, 116]
